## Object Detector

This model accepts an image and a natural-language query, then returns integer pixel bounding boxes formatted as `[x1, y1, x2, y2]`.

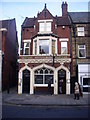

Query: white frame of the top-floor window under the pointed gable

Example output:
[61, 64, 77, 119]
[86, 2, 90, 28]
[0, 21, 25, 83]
[38, 19, 53, 34]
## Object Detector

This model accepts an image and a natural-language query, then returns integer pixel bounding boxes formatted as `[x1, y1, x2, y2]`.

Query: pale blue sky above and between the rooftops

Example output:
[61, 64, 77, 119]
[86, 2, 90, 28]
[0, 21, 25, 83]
[0, 0, 90, 53]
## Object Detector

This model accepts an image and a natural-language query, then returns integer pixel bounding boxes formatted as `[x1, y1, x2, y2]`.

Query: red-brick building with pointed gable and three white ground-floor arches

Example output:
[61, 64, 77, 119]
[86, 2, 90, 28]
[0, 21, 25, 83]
[18, 2, 72, 94]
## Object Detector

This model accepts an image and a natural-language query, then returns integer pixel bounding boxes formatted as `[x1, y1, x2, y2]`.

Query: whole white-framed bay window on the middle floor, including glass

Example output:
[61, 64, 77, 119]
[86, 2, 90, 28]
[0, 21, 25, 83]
[33, 36, 57, 55]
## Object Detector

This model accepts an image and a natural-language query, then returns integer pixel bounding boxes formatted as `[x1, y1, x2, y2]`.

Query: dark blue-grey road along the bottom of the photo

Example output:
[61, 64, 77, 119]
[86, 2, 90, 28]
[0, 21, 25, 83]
[2, 104, 88, 118]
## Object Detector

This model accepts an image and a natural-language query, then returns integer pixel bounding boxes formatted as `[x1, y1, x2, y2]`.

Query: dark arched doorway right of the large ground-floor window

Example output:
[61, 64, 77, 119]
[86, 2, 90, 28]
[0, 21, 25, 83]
[58, 69, 66, 94]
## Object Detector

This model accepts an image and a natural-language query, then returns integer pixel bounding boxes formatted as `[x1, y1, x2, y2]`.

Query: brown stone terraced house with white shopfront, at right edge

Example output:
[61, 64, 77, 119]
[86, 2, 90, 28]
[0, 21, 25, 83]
[68, 12, 90, 94]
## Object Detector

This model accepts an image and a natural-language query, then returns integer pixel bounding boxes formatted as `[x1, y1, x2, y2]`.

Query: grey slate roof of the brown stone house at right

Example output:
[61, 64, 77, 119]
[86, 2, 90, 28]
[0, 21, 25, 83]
[68, 12, 90, 23]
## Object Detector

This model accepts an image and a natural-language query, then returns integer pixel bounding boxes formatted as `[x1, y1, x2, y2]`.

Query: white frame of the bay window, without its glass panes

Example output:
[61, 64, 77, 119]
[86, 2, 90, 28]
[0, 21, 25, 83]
[33, 36, 57, 56]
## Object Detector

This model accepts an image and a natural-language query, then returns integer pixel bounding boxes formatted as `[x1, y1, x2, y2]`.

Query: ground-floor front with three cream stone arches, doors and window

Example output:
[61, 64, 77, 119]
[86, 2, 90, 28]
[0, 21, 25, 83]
[18, 64, 70, 94]
